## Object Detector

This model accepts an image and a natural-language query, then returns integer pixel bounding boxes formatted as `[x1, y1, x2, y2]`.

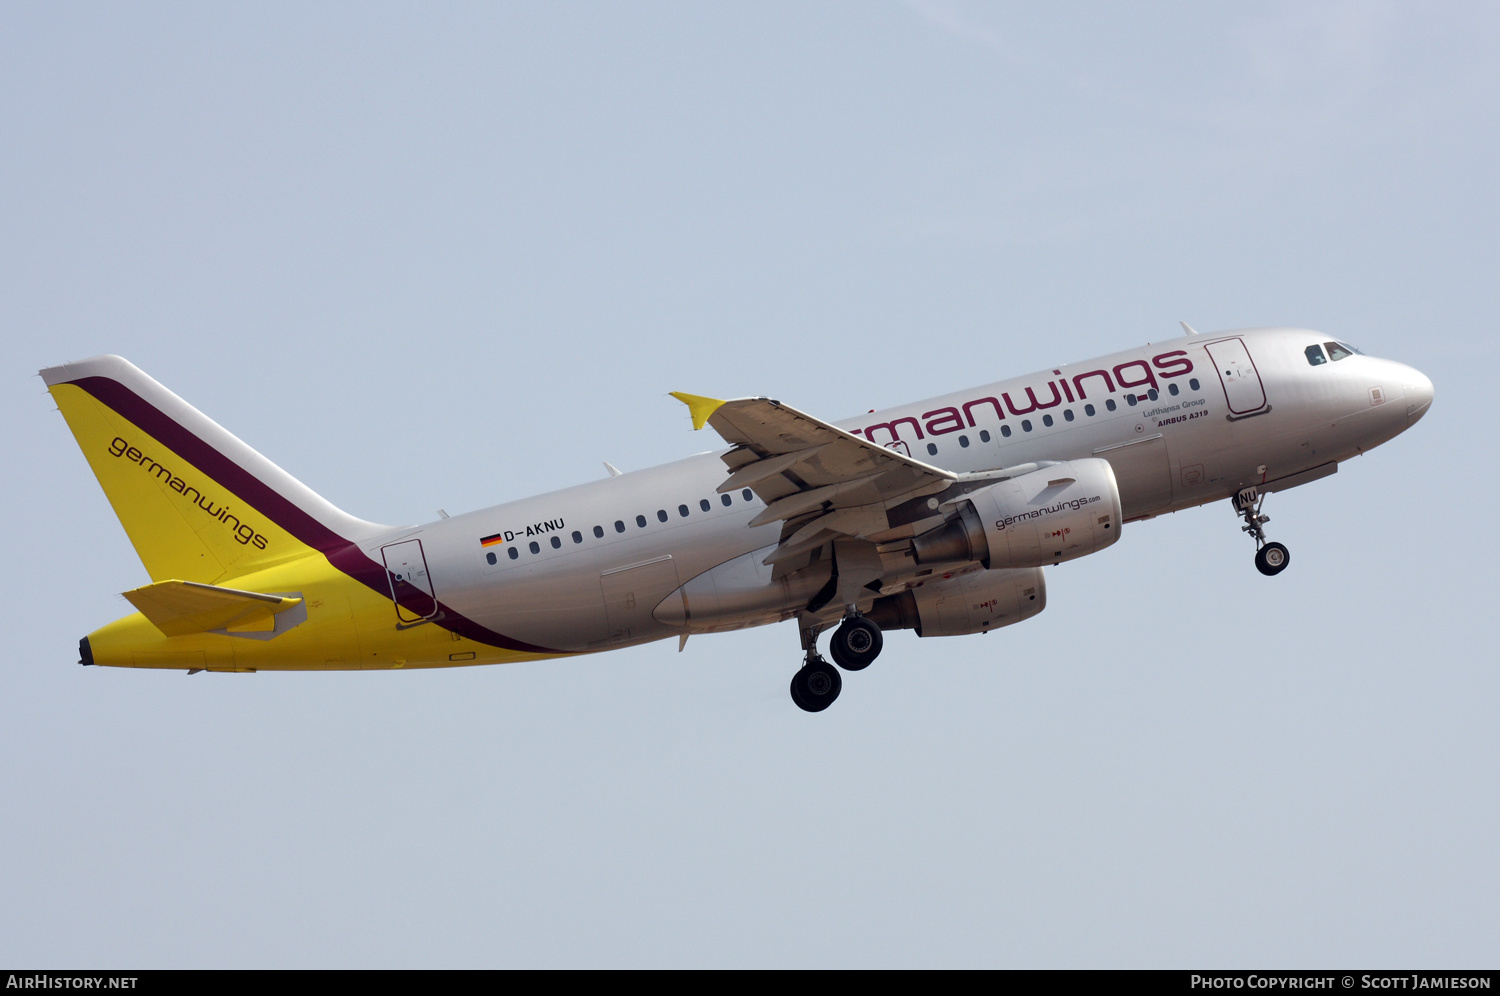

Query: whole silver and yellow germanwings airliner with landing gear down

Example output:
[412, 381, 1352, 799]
[41, 323, 1433, 713]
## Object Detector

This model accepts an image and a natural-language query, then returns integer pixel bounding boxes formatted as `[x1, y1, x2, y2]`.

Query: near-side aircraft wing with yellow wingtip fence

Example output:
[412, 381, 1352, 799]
[672, 392, 960, 564]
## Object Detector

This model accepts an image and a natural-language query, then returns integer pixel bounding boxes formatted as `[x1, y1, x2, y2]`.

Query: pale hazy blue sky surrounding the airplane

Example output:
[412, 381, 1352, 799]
[0, 0, 1500, 968]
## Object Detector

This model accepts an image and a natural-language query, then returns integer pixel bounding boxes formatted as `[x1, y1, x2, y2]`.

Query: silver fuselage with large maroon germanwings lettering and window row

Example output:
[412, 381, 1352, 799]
[363, 329, 1433, 653]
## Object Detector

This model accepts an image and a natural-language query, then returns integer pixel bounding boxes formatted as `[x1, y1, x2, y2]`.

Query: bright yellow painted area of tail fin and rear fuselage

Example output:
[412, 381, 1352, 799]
[51, 384, 554, 671]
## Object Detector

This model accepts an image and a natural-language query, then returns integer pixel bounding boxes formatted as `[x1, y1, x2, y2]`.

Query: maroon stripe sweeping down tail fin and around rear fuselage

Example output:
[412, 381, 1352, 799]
[69, 377, 570, 654]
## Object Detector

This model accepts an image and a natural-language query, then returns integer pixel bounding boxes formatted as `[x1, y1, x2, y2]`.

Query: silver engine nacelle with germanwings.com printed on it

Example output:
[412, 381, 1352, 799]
[912, 458, 1121, 570]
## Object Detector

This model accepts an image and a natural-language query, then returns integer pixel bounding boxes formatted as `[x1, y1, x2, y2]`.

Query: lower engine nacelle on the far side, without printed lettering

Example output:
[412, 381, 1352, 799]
[866, 567, 1047, 636]
